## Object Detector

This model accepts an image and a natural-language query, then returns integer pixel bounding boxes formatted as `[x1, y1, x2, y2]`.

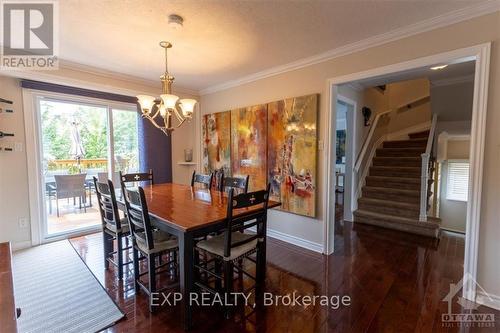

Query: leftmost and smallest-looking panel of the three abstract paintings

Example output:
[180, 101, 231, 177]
[202, 111, 231, 176]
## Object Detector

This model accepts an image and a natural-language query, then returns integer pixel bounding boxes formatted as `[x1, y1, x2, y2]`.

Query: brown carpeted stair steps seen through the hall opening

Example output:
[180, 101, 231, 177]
[354, 131, 439, 238]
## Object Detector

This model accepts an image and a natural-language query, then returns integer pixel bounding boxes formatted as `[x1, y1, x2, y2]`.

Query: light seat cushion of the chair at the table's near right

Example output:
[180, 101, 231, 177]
[196, 232, 258, 261]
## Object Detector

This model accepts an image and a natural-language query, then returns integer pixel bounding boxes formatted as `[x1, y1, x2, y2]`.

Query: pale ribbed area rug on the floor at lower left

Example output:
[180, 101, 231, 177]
[13, 240, 124, 333]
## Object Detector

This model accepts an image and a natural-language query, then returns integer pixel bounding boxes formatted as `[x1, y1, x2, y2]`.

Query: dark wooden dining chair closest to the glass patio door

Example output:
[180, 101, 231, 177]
[93, 177, 133, 280]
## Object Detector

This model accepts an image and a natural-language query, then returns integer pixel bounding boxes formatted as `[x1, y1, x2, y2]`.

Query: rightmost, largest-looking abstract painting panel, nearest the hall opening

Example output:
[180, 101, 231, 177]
[268, 94, 318, 217]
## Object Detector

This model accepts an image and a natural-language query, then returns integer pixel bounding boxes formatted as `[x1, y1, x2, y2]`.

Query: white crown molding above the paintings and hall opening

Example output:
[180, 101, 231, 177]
[199, 0, 500, 95]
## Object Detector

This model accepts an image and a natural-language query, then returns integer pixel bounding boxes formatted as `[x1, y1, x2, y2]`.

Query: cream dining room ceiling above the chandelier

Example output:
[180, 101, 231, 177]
[59, 0, 496, 90]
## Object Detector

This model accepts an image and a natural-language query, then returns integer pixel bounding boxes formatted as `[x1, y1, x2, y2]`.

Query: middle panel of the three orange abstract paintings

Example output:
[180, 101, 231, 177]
[231, 104, 267, 191]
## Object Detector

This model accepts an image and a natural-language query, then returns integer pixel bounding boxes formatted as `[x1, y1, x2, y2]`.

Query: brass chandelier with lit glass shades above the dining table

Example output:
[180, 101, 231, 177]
[137, 41, 196, 135]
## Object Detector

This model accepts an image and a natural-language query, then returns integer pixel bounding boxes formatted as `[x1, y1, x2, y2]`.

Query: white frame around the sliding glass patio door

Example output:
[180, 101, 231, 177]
[23, 89, 137, 245]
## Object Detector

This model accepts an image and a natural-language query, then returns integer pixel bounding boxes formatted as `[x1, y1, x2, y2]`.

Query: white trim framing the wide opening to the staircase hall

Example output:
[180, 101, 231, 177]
[324, 43, 491, 301]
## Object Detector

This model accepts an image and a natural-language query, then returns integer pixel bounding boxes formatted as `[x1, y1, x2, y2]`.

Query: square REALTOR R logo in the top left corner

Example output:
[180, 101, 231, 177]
[0, 0, 59, 70]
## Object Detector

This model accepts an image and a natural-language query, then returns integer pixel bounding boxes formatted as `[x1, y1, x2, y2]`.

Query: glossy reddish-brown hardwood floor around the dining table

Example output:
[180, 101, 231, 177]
[71, 221, 500, 332]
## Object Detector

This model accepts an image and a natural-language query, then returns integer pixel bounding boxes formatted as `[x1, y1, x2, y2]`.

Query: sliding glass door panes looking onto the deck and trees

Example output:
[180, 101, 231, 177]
[36, 97, 139, 239]
